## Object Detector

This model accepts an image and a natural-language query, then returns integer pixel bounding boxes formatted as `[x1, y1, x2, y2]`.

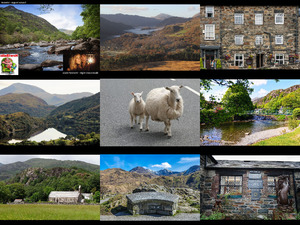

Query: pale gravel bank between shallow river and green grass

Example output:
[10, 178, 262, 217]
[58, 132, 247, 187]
[236, 127, 291, 145]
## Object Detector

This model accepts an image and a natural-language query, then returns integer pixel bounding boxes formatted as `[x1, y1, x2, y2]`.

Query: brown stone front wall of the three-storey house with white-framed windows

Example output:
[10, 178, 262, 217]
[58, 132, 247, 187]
[220, 6, 298, 68]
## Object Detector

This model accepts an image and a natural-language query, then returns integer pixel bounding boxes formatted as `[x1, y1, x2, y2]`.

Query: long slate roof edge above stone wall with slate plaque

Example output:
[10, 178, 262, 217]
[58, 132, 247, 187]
[206, 160, 300, 170]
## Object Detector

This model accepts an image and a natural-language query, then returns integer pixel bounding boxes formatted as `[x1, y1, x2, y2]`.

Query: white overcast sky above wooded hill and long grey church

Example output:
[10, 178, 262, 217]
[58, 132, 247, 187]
[0, 155, 100, 165]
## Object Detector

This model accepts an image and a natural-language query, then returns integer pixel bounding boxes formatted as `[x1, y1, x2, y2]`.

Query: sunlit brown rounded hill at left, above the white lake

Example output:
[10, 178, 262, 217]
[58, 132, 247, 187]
[0, 94, 56, 117]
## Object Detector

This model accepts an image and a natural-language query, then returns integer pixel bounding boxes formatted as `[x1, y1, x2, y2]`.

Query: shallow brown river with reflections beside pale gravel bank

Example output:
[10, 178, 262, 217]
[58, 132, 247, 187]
[200, 120, 287, 145]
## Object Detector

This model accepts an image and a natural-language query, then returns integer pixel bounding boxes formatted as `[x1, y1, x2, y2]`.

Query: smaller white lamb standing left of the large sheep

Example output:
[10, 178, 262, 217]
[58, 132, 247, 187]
[128, 92, 145, 131]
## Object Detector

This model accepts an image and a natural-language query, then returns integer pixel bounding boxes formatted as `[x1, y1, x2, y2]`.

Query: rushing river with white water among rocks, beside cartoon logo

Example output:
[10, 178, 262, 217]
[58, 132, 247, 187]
[0, 46, 63, 71]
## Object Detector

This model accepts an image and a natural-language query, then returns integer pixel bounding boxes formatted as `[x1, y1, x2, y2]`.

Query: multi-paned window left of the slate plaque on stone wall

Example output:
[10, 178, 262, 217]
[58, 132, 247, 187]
[220, 176, 243, 194]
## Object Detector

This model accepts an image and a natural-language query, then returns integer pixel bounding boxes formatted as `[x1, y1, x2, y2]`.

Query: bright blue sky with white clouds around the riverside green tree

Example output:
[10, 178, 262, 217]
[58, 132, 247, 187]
[202, 79, 300, 100]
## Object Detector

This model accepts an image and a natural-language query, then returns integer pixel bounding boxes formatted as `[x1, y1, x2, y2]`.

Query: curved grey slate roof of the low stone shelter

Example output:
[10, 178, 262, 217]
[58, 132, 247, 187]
[126, 192, 179, 203]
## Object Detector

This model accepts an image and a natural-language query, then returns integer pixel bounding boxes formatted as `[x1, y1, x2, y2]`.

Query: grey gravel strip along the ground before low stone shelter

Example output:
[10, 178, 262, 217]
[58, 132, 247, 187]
[100, 213, 200, 221]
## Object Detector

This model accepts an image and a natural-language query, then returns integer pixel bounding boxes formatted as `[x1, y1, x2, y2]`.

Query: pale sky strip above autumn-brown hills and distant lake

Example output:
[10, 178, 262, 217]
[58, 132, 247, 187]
[100, 4, 200, 18]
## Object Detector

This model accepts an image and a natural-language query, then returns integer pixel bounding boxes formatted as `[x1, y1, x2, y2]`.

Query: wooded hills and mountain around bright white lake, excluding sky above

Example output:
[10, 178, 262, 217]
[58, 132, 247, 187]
[0, 83, 100, 145]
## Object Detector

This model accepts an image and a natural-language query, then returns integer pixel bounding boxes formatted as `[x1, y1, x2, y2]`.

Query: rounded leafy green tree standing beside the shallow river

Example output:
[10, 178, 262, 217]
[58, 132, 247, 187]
[222, 83, 254, 115]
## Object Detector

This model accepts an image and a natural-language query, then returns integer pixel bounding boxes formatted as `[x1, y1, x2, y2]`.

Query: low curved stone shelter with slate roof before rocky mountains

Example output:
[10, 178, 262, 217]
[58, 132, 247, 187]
[126, 192, 179, 216]
